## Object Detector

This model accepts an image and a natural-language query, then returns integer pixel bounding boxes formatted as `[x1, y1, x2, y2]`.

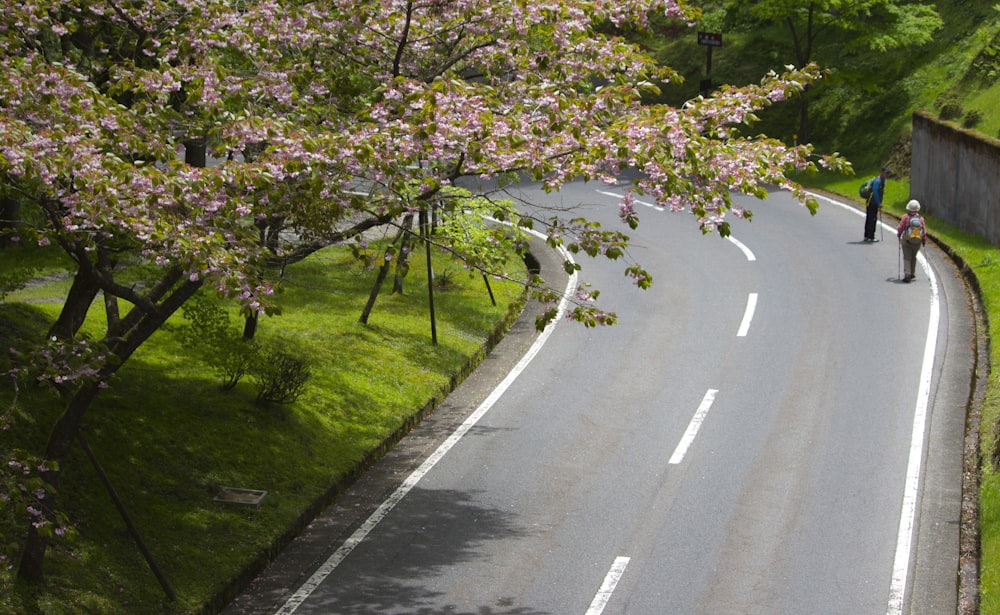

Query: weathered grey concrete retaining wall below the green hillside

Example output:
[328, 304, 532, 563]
[910, 111, 1000, 246]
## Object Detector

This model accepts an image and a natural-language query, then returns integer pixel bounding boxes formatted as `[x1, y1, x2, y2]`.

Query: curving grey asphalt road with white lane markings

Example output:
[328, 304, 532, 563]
[224, 184, 974, 615]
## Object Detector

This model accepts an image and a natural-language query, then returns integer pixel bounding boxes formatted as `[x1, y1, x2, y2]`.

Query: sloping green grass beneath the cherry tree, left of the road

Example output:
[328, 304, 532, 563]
[0, 243, 525, 614]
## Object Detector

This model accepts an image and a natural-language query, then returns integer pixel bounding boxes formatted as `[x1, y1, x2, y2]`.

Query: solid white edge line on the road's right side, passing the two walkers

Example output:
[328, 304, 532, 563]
[809, 192, 941, 615]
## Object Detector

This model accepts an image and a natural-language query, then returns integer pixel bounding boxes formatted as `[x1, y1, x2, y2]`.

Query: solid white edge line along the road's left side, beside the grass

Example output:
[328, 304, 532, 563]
[275, 230, 577, 615]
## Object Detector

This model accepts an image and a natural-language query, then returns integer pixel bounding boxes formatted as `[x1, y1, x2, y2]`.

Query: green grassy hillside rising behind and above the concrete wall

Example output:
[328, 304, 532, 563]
[644, 0, 1000, 175]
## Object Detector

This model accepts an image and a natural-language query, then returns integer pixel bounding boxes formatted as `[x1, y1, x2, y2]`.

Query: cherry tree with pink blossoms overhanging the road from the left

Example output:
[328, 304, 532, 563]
[0, 0, 847, 581]
